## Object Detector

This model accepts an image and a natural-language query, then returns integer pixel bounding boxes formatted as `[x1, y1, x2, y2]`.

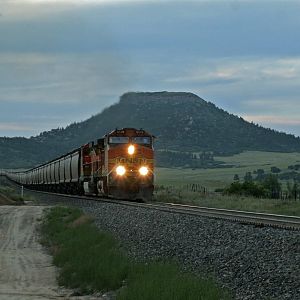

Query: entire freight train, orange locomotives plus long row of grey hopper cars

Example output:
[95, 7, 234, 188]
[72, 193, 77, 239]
[7, 128, 154, 200]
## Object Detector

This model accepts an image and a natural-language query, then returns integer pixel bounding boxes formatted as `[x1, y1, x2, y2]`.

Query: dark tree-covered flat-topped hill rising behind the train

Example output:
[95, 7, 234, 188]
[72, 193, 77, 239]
[0, 92, 300, 168]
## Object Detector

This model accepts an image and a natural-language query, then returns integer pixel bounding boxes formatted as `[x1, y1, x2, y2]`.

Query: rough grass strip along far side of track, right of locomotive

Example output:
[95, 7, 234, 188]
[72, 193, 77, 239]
[154, 187, 300, 216]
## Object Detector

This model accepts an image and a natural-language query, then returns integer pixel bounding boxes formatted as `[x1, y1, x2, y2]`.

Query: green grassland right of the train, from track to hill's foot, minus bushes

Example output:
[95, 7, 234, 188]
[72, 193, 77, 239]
[155, 151, 300, 216]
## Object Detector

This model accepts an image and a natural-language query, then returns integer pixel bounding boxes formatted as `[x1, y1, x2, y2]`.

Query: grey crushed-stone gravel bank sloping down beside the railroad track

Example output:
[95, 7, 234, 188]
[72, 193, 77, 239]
[1, 180, 300, 300]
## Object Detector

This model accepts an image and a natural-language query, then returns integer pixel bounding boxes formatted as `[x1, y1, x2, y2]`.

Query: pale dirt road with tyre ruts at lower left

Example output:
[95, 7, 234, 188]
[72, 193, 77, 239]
[0, 206, 62, 300]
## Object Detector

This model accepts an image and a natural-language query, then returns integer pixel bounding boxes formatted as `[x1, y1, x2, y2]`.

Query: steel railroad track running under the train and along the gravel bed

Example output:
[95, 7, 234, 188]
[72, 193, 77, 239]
[20, 186, 300, 230]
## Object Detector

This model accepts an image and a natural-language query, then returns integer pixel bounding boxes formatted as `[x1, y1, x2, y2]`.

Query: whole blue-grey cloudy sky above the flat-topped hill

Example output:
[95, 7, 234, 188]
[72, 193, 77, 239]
[0, 0, 300, 137]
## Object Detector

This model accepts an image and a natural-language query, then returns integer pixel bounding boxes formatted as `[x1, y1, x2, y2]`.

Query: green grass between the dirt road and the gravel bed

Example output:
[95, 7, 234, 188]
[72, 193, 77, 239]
[42, 207, 230, 300]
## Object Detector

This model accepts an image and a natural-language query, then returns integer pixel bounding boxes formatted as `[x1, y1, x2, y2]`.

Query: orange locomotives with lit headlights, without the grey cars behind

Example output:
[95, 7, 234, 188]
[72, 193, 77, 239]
[81, 128, 154, 200]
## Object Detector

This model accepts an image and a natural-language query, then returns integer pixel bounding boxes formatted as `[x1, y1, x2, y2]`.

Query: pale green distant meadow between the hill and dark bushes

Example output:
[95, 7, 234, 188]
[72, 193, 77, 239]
[156, 151, 300, 190]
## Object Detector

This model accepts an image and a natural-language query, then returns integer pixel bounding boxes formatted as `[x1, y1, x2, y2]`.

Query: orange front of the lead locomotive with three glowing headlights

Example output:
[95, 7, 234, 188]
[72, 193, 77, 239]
[105, 128, 154, 200]
